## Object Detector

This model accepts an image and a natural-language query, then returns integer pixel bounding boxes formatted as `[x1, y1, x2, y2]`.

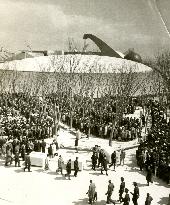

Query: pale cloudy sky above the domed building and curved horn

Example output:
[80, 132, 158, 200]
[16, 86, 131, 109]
[0, 0, 170, 57]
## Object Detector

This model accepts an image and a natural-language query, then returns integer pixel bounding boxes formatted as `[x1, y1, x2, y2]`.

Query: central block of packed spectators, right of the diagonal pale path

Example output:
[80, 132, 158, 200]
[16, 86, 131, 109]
[62, 94, 141, 141]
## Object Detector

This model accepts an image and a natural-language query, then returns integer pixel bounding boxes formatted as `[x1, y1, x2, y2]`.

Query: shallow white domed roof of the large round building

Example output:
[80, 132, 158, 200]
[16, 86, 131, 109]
[0, 54, 152, 73]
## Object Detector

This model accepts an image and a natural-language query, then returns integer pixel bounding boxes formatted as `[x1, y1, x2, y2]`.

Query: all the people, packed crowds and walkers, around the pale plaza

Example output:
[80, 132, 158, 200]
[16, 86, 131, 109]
[0, 93, 170, 205]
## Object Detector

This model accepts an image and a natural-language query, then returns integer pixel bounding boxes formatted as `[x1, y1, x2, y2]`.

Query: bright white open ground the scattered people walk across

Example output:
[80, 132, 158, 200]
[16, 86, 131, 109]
[0, 125, 170, 205]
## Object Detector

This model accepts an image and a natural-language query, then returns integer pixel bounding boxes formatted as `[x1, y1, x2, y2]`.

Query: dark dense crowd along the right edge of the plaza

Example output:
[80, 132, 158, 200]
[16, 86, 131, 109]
[136, 100, 170, 185]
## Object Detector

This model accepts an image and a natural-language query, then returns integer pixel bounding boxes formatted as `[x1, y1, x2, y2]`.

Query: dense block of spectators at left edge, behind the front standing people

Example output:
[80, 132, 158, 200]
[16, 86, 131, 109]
[0, 93, 55, 140]
